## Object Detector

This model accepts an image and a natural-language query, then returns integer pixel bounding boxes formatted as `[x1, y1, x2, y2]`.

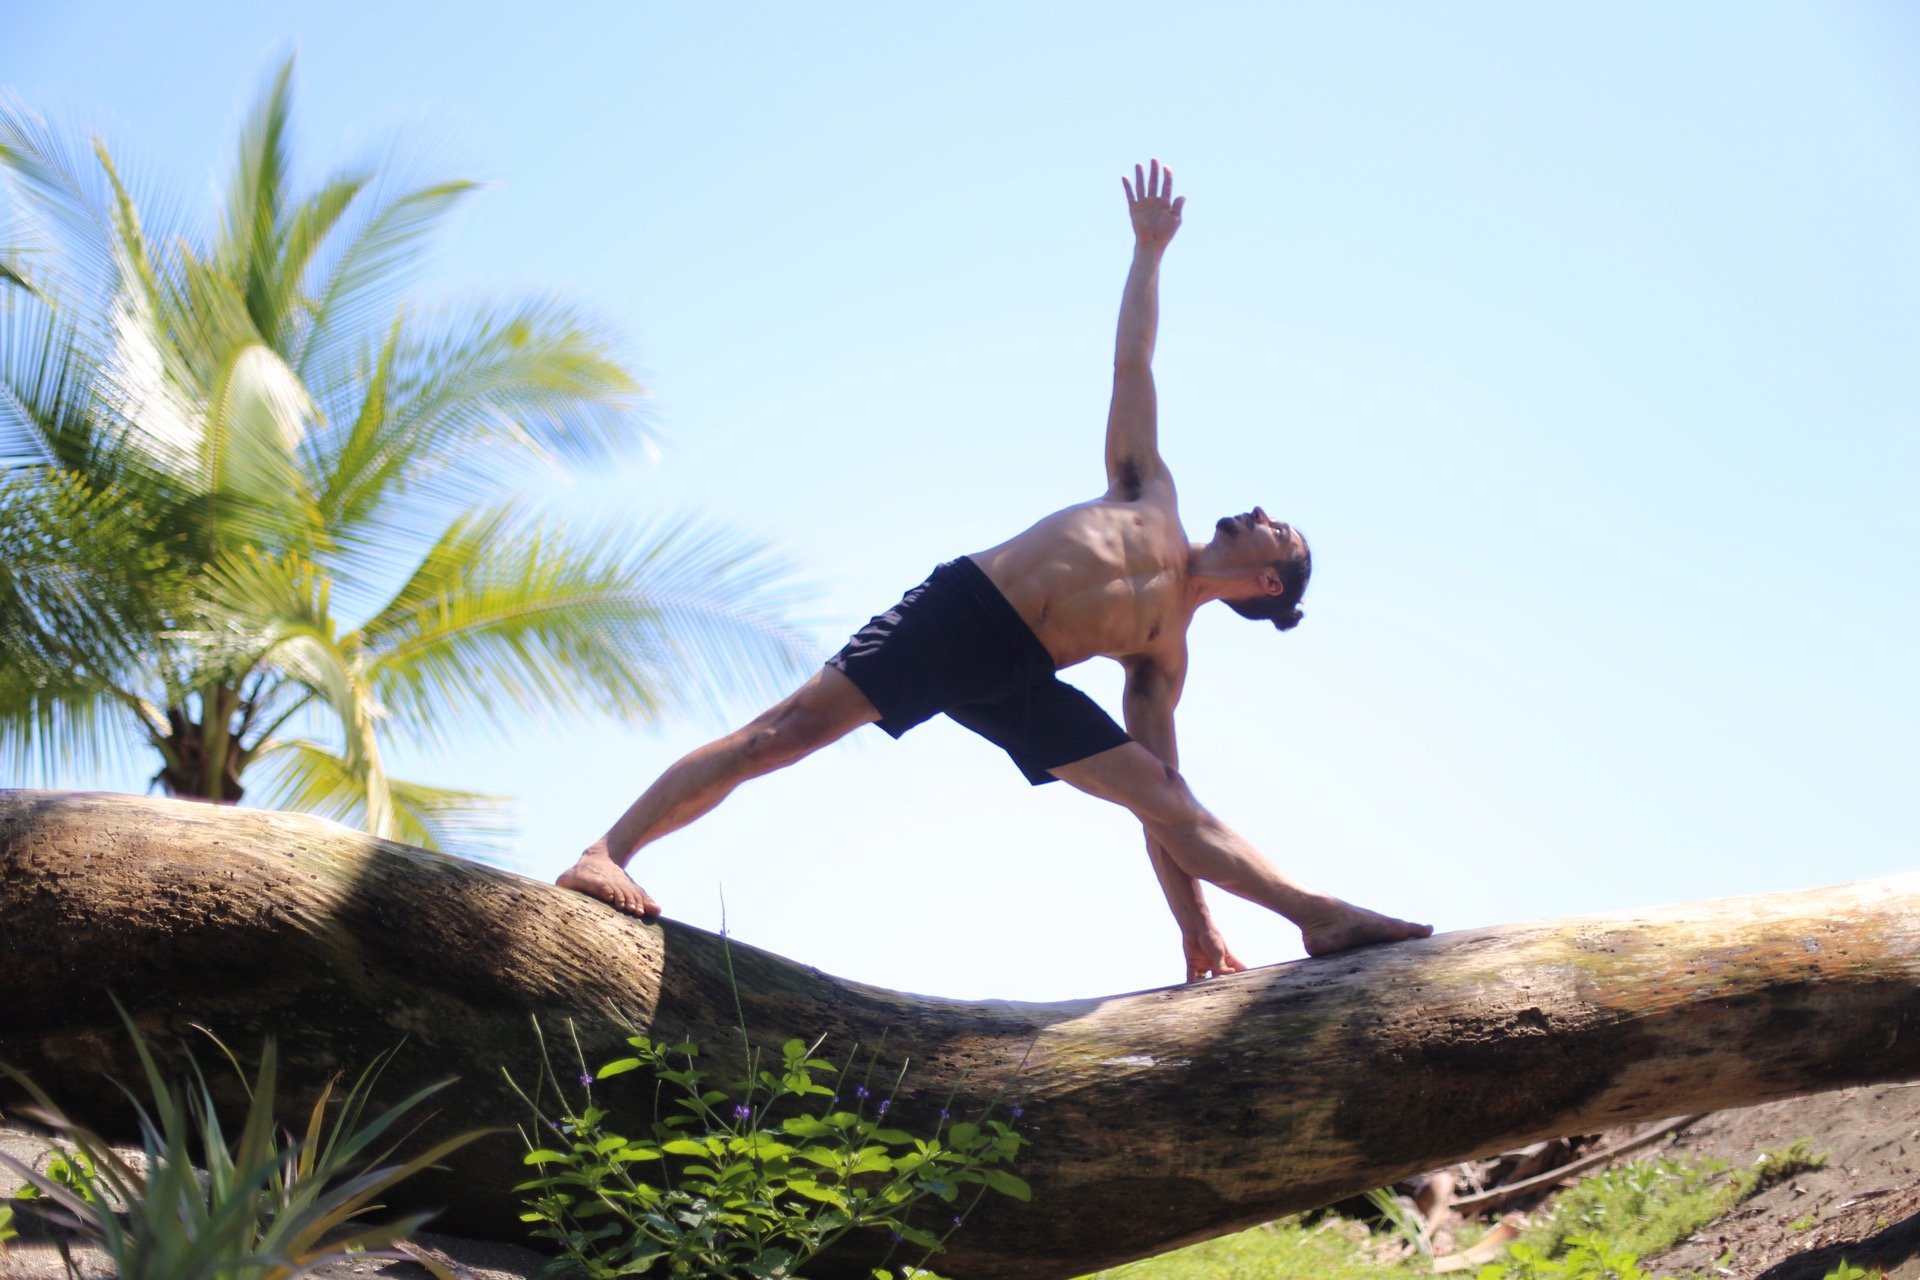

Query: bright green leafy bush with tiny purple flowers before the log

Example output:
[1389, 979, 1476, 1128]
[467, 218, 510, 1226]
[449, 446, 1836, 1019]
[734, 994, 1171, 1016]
[509, 1023, 1031, 1280]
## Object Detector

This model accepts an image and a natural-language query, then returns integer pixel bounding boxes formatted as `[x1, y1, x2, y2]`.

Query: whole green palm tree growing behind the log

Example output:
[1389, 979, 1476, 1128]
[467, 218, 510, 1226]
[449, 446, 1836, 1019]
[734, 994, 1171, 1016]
[0, 61, 803, 848]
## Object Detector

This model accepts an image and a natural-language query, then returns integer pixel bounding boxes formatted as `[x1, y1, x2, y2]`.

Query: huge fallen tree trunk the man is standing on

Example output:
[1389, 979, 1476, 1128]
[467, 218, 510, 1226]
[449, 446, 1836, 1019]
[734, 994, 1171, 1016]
[0, 793, 1920, 1280]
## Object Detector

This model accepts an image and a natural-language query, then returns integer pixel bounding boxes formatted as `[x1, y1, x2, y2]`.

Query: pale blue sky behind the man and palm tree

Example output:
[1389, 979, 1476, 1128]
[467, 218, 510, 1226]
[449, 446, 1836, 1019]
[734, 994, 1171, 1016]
[0, 0, 1920, 998]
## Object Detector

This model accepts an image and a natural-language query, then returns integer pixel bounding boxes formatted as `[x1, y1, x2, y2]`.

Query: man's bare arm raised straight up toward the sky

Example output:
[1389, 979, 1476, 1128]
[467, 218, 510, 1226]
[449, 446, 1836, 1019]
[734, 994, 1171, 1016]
[1106, 159, 1187, 503]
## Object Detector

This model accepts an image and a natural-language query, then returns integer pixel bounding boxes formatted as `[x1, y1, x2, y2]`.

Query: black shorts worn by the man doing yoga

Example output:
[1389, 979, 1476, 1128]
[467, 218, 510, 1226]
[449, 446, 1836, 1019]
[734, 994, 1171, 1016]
[828, 557, 1133, 787]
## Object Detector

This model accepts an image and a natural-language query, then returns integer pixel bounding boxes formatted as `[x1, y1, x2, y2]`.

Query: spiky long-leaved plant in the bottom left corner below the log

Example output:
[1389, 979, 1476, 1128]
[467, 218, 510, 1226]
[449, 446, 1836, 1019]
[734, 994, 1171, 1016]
[0, 1013, 480, 1280]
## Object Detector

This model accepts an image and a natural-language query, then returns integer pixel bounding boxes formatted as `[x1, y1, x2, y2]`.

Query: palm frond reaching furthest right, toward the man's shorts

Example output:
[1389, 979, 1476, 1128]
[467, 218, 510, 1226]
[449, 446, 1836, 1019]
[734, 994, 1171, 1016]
[353, 509, 810, 756]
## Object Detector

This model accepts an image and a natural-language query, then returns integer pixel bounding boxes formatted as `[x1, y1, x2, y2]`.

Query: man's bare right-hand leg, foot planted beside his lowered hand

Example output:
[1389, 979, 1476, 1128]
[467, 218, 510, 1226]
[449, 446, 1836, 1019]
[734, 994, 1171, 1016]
[1052, 743, 1432, 956]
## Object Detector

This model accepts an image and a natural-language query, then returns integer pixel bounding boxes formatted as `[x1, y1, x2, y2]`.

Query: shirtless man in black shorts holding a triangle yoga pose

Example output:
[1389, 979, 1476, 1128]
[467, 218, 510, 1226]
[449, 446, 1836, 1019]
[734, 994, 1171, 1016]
[559, 161, 1432, 983]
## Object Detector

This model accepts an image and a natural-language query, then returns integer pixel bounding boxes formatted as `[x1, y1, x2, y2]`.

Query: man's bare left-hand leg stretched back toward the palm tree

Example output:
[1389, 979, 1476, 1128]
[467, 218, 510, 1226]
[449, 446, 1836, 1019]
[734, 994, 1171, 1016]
[557, 666, 879, 919]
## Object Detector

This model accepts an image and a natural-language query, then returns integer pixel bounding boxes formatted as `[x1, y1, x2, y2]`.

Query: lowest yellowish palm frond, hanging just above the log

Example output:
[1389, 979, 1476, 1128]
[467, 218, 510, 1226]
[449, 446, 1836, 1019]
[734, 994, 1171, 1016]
[252, 739, 522, 867]
